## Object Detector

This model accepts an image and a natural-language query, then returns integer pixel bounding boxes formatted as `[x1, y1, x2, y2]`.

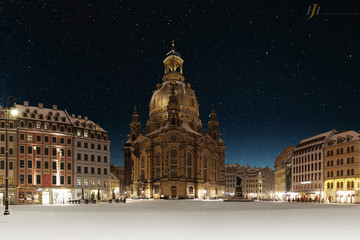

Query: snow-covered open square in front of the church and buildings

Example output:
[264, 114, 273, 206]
[0, 200, 360, 240]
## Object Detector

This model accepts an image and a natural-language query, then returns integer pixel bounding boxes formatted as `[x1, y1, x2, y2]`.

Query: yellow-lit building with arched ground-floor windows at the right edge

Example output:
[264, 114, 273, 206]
[324, 131, 360, 203]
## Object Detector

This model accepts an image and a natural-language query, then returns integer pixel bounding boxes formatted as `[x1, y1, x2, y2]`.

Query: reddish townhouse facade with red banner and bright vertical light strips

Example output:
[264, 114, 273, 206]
[16, 101, 74, 204]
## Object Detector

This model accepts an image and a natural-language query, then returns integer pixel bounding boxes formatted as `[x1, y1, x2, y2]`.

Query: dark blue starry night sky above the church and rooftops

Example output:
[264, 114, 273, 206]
[0, 0, 360, 167]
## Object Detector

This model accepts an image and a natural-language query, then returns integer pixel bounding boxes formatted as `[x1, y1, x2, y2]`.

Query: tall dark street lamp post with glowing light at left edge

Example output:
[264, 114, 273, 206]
[4, 97, 19, 215]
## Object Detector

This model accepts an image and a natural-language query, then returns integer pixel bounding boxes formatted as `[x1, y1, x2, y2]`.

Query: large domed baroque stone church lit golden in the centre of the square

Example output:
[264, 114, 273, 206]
[123, 43, 226, 199]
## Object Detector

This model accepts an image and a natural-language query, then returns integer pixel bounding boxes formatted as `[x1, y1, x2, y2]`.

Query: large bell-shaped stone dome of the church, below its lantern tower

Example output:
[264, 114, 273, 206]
[149, 80, 199, 122]
